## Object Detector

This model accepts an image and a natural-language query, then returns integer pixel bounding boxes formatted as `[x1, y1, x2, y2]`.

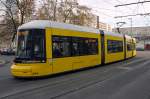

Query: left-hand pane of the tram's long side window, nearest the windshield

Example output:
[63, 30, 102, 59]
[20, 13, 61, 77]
[52, 36, 71, 58]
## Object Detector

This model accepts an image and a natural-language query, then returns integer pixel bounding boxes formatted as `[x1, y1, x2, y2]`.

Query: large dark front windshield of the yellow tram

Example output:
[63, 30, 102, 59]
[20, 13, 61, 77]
[15, 29, 45, 63]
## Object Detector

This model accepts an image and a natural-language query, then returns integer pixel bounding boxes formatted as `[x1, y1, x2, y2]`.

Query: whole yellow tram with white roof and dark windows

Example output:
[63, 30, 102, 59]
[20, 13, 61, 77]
[11, 20, 136, 77]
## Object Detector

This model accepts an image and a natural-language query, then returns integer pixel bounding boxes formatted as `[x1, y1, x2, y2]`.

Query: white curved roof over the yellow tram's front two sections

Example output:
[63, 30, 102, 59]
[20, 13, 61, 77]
[18, 20, 123, 37]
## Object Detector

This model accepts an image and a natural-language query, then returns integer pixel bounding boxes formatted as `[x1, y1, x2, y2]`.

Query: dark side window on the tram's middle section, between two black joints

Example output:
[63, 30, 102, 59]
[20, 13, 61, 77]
[107, 40, 123, 53]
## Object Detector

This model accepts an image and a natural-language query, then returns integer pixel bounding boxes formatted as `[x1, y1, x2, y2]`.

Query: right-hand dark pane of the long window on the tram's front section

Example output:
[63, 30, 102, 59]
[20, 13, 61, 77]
[72, 37, 98, 56]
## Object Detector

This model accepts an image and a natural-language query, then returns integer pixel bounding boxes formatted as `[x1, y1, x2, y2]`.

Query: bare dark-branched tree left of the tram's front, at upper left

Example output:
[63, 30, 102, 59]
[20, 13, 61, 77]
[0, 0, 34, 40]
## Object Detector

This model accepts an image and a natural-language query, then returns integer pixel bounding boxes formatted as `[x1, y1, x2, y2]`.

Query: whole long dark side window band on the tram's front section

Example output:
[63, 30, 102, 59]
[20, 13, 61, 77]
[52, 36, 98, 58]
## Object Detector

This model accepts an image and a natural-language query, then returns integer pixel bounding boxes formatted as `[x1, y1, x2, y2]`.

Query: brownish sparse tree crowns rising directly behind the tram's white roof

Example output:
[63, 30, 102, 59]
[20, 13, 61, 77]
[37, 0, 96, 27]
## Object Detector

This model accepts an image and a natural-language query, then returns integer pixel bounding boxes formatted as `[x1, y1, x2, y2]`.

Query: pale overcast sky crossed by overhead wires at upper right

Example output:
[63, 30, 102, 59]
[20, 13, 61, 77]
[79, 0, 150, 27]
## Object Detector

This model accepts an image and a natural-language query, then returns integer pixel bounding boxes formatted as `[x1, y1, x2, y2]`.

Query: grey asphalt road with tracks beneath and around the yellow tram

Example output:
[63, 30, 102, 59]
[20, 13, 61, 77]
[0, 52, 150, 99]
